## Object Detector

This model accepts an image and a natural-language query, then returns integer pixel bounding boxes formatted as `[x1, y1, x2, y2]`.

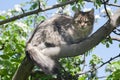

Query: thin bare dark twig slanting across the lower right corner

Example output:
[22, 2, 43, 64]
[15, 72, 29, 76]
[76, 54, 120, 76]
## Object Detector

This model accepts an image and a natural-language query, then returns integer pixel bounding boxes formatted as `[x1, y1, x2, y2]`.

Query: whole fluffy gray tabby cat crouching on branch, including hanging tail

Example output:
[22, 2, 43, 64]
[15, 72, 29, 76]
[27, 9, 94, 74]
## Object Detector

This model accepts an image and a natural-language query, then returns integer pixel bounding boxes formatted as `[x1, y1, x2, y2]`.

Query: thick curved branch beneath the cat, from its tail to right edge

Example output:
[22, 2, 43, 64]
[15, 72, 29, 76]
[39, 9, 120, 58]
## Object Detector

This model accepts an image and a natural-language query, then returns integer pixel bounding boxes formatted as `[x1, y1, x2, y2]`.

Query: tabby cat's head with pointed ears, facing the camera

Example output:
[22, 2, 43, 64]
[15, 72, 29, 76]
[73, 9, 94, 30]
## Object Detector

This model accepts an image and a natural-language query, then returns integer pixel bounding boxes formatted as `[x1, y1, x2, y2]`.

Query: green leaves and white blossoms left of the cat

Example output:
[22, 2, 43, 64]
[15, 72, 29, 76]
[0, 1, 45, 80]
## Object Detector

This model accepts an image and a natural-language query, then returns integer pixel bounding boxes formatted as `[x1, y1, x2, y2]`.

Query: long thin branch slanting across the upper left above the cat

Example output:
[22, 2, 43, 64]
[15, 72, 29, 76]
[0, 0, 77, 25]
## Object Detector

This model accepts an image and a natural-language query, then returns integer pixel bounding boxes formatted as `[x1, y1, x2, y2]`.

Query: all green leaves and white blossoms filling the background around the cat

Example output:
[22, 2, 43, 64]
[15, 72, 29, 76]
[0, 0, 120, 80]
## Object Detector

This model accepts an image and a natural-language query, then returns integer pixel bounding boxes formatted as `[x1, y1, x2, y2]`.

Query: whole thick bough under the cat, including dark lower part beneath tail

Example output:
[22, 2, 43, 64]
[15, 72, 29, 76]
[12, 9, 120, 80]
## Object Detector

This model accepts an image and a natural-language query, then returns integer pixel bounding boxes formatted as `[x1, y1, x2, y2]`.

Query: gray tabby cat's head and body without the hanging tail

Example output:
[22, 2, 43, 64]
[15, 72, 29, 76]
[31, 9, 94, 48]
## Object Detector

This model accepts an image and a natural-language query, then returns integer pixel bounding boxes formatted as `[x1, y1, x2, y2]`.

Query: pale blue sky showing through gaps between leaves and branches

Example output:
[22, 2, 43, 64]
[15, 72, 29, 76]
[0, 0, 120, 79]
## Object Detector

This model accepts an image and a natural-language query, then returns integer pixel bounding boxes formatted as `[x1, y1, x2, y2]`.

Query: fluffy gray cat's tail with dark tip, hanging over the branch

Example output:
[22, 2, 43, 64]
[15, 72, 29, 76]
[26, 43, 59, 74]
